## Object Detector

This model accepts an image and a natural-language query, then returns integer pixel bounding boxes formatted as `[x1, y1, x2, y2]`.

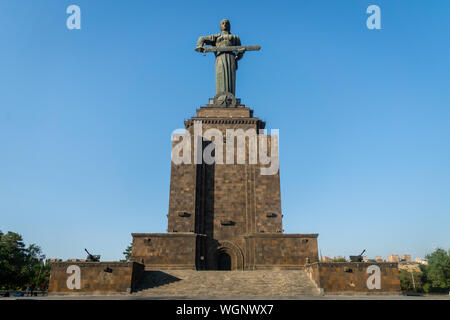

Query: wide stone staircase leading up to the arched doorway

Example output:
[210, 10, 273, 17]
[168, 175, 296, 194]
[133, 270, 320, 297]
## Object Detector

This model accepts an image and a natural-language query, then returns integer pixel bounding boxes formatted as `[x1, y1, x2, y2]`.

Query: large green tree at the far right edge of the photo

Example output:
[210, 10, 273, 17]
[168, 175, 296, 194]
[420, 248, 450, 292]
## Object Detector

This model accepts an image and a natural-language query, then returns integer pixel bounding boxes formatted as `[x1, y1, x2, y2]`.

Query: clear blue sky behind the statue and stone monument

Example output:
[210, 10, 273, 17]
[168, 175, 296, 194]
[0, 0, 450, 260]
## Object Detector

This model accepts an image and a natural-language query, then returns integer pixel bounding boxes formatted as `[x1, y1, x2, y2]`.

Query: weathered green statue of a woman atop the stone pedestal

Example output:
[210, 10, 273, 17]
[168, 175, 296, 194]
[197, 19, 245, 96]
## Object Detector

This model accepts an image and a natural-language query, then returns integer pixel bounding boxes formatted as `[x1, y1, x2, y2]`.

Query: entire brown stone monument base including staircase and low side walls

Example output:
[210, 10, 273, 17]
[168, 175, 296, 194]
[49, 99, 400, 297]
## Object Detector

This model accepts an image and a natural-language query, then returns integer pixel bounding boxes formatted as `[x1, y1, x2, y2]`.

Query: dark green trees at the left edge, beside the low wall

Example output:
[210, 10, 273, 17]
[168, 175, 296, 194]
[0, 231, 50, 289]
